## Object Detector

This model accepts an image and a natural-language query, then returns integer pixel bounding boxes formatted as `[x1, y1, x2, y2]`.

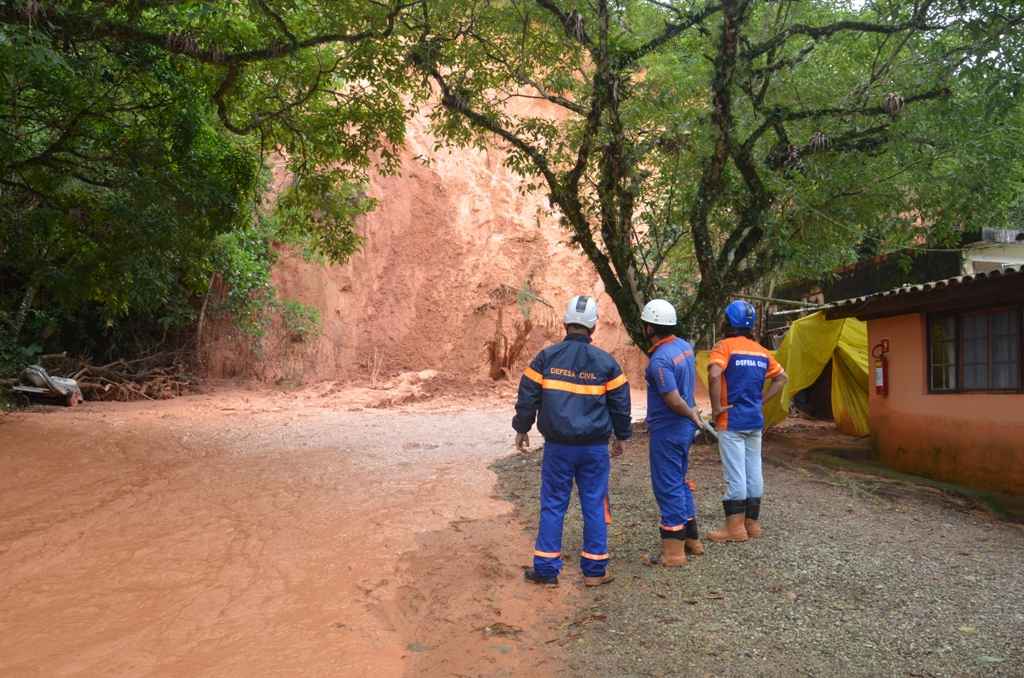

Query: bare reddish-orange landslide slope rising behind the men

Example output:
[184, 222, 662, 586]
[206, 103, 642, 383]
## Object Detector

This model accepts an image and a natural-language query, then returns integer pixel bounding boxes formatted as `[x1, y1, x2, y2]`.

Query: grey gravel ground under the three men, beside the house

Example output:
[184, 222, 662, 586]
[495, 433, 1024, 677]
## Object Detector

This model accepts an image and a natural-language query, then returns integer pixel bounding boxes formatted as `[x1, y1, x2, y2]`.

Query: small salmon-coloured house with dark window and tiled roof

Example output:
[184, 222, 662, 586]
[826, 265, 1024, 495]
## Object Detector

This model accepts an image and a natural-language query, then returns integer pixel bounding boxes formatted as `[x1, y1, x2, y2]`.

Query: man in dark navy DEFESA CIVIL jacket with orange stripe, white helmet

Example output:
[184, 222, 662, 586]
[512, 296, 632, 586]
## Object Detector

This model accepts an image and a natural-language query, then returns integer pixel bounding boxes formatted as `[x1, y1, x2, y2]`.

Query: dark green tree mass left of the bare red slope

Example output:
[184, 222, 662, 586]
[0, 0, 407, 363]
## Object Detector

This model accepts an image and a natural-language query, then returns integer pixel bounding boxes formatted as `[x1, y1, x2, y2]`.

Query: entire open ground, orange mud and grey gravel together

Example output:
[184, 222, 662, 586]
[0, 385, 1024, 678]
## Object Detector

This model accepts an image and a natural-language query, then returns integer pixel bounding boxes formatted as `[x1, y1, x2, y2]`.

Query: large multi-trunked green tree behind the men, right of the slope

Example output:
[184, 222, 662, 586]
[410, 0, 1024, 344]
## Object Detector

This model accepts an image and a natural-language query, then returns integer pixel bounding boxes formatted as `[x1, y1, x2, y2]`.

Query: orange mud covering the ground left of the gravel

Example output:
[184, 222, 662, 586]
[0, 391, 574, 677]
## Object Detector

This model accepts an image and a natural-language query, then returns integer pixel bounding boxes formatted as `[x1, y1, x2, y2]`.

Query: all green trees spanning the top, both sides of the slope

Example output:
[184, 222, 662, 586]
[0, 0, 1024, 369]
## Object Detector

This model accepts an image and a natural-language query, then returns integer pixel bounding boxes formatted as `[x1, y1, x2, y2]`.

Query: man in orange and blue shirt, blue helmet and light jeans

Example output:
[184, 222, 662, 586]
[708, 300, 787, 542]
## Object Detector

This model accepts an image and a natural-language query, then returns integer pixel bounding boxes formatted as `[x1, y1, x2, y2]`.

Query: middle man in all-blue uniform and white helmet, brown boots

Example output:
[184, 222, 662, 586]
[640, 299, 703, 567]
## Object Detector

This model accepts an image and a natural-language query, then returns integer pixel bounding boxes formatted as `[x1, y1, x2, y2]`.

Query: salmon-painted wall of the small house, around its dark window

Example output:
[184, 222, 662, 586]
[867, 314, 1024, 495]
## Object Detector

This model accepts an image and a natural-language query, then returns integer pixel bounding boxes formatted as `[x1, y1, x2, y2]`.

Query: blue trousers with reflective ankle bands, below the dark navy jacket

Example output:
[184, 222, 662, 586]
[534, 442, 610, 577]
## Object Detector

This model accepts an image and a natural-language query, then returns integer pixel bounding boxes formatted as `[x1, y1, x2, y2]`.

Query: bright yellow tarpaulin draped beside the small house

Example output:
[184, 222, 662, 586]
[697, 313, 870, 435]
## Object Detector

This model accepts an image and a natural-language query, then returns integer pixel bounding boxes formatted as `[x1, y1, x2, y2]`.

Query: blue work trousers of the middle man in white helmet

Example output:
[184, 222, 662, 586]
[650, 421, 697, 532]
